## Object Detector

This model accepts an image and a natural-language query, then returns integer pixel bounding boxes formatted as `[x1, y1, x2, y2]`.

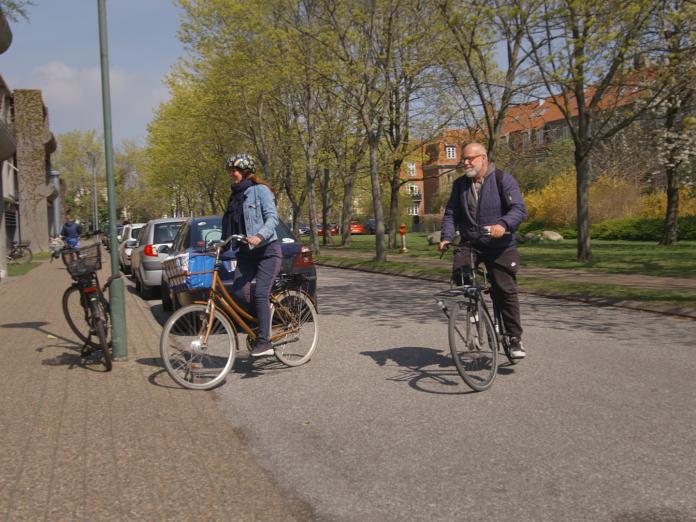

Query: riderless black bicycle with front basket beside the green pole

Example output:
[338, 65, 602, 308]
[60, 243, 121, 371]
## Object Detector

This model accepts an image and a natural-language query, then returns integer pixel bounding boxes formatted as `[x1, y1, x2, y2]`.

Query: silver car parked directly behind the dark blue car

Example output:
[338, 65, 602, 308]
[131, 218, 185, 299]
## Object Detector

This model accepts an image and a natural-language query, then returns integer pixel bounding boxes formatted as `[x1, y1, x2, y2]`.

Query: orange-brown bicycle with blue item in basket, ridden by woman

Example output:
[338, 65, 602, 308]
[160, 235, 319, 390]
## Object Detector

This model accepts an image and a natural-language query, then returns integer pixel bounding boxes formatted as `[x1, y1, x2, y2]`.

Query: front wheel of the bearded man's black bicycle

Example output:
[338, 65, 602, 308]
[448, 302, 498, 391]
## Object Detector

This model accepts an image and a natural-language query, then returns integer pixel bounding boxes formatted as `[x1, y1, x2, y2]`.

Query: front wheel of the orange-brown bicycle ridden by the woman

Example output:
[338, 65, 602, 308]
[160, 304, 238, 390]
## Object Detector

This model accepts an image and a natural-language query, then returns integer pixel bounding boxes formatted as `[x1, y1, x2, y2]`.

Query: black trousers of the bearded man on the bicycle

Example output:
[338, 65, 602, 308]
[452, 246, 522, 337]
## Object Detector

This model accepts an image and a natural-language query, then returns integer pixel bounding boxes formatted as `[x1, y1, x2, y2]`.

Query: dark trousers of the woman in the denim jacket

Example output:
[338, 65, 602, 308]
[232, 241, 282, 345]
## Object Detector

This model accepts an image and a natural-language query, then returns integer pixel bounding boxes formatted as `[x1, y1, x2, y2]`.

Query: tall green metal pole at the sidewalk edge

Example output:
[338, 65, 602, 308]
[97, 0, 128, 361]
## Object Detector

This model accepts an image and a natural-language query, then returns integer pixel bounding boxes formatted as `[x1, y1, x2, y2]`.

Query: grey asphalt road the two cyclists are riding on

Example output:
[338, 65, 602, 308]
[137, 268, 696, 522]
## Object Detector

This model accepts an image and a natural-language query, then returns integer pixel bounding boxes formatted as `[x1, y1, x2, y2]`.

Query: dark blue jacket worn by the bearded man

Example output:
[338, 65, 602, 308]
[440, 166, 527, 249]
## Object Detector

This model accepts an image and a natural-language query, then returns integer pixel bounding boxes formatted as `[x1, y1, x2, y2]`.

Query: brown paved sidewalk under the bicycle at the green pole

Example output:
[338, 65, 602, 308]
[0, 262, 312, 521]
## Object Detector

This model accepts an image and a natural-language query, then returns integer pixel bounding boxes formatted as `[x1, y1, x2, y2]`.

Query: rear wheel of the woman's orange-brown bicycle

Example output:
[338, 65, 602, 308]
[271, 290, 319, 366]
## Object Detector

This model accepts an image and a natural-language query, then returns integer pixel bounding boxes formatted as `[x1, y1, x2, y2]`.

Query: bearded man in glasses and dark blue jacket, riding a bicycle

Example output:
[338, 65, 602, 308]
[438, 143, 527, 359]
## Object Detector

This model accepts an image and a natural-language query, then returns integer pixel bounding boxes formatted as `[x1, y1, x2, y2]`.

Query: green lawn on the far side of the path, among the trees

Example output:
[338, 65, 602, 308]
[322, 233, 696, 278]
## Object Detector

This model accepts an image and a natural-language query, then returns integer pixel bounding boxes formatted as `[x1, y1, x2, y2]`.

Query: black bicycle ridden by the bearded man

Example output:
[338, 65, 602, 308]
[433, 238, 517, 391]
